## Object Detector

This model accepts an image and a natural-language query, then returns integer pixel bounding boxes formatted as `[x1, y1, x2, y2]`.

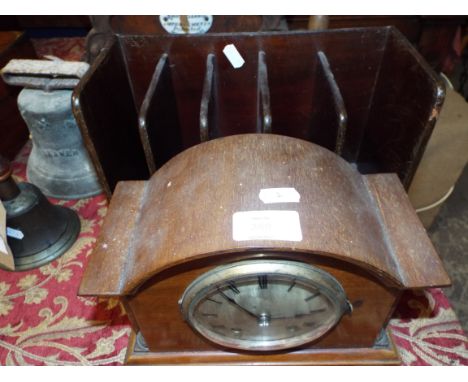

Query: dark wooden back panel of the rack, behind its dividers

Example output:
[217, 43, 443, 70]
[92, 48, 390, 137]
[119, 28, 390, 160]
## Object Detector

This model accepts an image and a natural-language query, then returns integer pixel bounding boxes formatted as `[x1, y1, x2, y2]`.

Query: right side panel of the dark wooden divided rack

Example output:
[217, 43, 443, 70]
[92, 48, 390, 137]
[358, 31, 445, 187]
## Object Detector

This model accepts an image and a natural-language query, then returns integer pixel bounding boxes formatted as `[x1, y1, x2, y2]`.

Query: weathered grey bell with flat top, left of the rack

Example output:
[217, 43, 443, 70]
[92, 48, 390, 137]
[0, 59, 102, 199]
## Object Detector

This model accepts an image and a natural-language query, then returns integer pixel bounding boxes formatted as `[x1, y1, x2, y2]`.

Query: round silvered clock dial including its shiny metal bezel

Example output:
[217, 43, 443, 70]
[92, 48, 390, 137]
[180, 260, 349, 351]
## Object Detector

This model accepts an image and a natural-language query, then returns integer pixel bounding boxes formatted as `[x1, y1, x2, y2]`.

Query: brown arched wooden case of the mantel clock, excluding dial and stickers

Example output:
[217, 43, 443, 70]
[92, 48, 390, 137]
[80, 134, 450, 364]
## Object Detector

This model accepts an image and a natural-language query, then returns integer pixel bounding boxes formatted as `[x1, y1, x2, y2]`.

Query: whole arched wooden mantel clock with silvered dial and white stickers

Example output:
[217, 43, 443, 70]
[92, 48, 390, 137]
[80, 134, 450, 364]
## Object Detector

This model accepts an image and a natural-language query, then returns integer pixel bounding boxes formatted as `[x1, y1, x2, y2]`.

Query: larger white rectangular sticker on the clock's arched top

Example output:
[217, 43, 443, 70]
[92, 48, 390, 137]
[232, 210, 302, 241]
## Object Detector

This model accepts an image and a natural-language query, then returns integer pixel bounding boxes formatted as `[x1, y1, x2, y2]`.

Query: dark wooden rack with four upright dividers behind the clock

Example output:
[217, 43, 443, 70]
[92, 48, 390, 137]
[77, 28, 444, 195]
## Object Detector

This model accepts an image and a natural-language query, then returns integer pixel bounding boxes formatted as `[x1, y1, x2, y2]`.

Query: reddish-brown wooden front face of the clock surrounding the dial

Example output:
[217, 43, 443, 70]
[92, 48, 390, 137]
[126, 252, 400, 352]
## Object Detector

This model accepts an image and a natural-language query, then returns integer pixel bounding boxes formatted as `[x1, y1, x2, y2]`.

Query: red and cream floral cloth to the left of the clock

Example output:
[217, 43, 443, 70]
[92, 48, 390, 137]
[0, 144, 129, 365]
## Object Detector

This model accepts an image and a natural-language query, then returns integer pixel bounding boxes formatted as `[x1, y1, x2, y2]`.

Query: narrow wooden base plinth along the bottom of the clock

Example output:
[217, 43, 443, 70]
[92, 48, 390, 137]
[125, 331, 401, 366]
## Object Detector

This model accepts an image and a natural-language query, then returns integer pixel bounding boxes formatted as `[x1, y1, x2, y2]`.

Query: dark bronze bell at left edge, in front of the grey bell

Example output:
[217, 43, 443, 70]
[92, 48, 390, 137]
[0, 156, 80, 271]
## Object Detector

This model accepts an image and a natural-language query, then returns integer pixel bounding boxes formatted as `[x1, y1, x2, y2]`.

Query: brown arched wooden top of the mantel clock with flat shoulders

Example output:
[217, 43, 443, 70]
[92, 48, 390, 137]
[82, 134, 449, 295]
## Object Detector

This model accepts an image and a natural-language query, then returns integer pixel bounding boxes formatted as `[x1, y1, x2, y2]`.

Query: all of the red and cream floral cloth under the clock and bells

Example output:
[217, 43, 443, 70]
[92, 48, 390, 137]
[0, 39, 468, 365]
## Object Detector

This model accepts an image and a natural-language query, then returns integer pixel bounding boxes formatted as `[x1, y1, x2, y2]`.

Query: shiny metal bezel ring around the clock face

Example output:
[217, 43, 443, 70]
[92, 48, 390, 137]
[179, 259, 350, 351]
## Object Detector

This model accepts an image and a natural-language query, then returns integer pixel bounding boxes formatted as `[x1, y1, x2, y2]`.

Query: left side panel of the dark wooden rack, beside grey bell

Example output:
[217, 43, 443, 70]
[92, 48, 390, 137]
[72, 39, 149, 197]
